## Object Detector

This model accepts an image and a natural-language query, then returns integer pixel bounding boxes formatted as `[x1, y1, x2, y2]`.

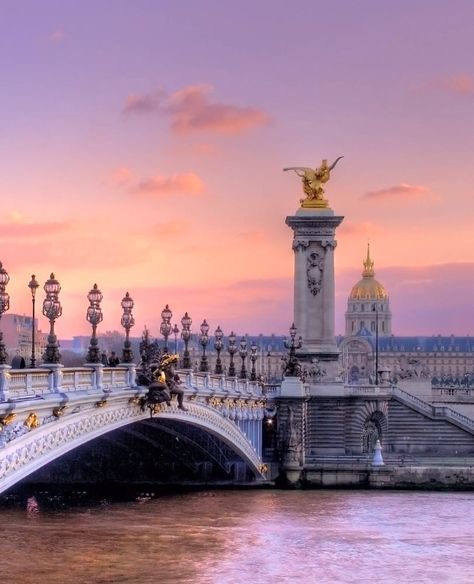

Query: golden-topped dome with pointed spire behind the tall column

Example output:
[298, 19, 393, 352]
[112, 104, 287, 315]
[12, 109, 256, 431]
[346, 245, 392, 336]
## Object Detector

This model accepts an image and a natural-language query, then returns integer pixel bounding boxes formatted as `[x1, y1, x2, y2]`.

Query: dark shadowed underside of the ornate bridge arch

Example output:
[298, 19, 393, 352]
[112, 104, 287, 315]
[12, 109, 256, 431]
[19, 418, 254, 488]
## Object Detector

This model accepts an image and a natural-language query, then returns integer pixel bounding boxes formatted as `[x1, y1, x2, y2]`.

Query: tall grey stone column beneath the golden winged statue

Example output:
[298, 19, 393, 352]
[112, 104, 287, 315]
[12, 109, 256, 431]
[286, 206, 344, 362]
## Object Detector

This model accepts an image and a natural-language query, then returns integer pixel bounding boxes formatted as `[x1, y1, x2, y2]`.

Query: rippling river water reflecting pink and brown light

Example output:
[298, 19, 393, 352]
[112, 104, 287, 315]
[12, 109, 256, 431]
[0, 490, 474, 584]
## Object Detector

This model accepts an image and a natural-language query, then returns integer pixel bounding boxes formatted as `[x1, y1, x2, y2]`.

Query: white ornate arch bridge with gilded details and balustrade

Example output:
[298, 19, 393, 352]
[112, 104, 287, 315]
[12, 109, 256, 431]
[0, 363, 267, 493]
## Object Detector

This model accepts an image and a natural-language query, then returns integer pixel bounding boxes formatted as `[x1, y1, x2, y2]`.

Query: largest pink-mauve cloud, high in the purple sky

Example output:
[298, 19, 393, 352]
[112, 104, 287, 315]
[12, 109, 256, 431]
[123, 84, 269, 134]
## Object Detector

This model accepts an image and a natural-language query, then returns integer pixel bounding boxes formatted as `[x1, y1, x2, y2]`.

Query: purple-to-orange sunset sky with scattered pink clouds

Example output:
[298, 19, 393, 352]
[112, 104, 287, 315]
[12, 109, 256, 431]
[0, 0, 474, 338]
